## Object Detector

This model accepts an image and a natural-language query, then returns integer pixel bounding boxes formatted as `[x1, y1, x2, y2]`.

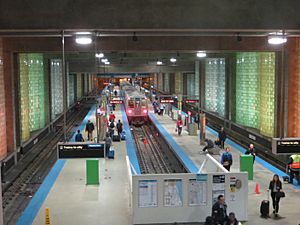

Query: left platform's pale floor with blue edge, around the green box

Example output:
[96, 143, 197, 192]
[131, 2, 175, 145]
[17, 107, 132, 225]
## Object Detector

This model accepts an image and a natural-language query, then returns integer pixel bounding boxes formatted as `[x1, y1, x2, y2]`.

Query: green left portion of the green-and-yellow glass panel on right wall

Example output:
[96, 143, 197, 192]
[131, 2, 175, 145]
[236, 52, 260, 129]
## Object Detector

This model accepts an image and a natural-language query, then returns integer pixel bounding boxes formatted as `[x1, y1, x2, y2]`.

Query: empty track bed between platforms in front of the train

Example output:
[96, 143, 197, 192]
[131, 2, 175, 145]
[132, 125, 173, 174]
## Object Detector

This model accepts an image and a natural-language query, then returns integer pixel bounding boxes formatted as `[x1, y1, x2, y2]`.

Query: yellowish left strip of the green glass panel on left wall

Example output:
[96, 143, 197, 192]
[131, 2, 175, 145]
[19, 54, 30, 142]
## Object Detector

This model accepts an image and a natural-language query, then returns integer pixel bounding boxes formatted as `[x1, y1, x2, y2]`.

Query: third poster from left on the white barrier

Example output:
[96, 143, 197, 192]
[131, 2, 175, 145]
[189, 179, 207, 206]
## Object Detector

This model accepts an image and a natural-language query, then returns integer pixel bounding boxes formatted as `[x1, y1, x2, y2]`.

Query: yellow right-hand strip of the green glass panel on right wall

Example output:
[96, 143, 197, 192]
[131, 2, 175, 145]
[260, 53, 275, 137]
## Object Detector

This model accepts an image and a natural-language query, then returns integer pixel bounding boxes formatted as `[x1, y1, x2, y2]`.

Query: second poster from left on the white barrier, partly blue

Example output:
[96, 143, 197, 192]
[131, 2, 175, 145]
[164, 179, 182, 207]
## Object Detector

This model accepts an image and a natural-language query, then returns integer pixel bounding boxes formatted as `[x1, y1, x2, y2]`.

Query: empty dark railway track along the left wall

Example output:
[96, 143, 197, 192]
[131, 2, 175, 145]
[2, 104, 89, 225]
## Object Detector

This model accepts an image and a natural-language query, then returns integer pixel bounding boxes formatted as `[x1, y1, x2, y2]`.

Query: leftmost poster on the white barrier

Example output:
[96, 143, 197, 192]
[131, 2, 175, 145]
[139, 180, 157, 208]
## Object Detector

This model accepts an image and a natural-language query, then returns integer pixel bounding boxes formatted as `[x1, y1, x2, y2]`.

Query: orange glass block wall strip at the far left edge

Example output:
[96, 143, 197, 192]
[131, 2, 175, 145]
[0, 39, 7, 159]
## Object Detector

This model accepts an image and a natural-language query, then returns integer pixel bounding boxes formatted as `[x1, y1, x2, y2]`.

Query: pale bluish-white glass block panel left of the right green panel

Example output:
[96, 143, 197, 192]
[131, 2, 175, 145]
[205, 58, 225, 117]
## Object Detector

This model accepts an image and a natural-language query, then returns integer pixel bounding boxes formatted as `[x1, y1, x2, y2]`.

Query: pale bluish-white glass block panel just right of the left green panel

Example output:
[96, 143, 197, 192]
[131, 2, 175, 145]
[50, 59, 64, 120]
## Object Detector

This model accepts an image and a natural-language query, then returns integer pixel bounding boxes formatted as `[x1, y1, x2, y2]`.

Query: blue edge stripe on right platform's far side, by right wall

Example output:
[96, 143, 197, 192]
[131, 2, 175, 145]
[206, 126, 300, 189]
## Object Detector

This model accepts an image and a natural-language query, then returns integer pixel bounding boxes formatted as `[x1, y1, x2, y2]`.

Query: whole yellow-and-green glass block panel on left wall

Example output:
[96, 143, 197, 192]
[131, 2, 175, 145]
[19, 53, 46, 141]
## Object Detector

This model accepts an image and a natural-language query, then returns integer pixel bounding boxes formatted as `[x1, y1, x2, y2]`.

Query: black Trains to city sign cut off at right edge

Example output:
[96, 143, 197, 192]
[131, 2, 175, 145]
[272, 138, 300, 154]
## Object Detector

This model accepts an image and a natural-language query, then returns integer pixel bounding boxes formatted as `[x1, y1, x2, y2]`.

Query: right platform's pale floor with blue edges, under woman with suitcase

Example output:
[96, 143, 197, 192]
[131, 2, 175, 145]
[150, 113, 300, 225]
